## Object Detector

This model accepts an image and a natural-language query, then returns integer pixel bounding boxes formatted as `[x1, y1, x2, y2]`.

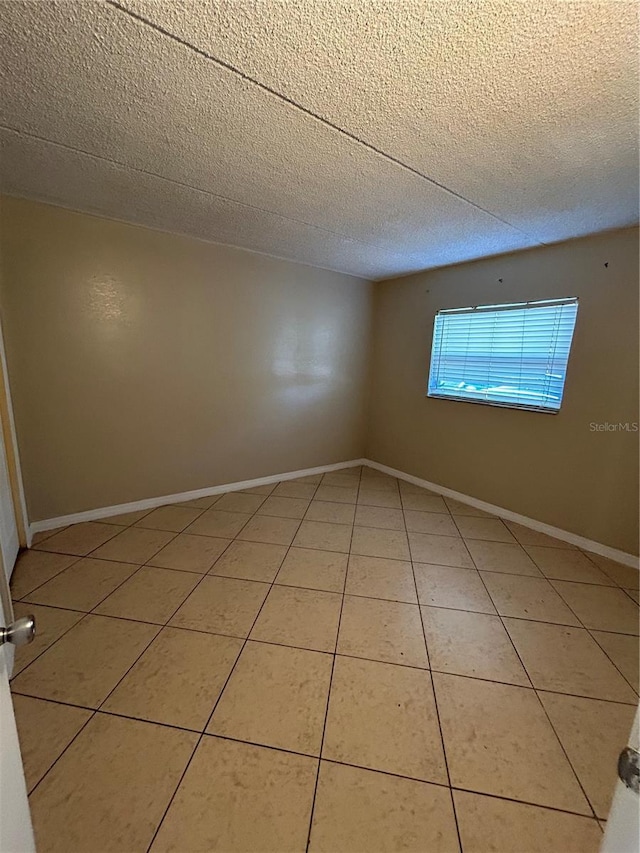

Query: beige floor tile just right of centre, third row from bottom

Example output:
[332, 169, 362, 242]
[338, 595, 429, 669]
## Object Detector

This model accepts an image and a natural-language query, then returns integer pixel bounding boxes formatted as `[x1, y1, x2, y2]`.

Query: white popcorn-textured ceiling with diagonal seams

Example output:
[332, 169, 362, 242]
[0, 0, 638, 278]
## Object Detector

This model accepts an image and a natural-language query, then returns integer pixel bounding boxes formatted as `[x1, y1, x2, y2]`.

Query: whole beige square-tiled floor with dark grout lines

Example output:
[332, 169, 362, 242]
[7, 468, 639, 853]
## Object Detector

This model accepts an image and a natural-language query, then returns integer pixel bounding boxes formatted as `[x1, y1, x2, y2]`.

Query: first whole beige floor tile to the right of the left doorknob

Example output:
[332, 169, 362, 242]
[13, 615, 158, 708]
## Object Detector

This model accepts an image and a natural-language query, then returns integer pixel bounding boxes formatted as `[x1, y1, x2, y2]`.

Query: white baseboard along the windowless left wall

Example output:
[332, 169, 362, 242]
[27, 459, 365, 546]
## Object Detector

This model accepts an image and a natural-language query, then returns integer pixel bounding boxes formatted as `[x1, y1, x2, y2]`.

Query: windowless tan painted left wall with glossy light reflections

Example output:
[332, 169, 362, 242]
[0, 198, 372, 521]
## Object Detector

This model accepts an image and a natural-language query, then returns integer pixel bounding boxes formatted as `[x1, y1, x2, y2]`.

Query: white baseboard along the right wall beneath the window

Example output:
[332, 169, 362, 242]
[360, 459, 640, 569]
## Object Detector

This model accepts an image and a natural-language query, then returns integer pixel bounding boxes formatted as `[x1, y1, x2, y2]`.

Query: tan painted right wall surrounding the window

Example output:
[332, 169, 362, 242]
[367, 229, 640, 554]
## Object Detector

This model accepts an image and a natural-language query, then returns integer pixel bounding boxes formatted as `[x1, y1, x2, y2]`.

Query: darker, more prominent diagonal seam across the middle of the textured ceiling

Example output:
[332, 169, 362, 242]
[105, 0, 545, 246]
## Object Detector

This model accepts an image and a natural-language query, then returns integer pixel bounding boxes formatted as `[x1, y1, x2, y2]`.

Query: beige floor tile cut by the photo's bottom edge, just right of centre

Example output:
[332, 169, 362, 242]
[309, 761, 460, 853]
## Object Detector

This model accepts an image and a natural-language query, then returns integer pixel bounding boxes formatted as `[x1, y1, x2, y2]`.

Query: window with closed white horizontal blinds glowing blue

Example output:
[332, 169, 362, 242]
[428, 299, 578, 412]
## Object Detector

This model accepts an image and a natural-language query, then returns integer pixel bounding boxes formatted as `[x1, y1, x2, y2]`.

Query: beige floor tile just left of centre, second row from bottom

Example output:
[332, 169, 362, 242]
[207, 641, 333, 755]
